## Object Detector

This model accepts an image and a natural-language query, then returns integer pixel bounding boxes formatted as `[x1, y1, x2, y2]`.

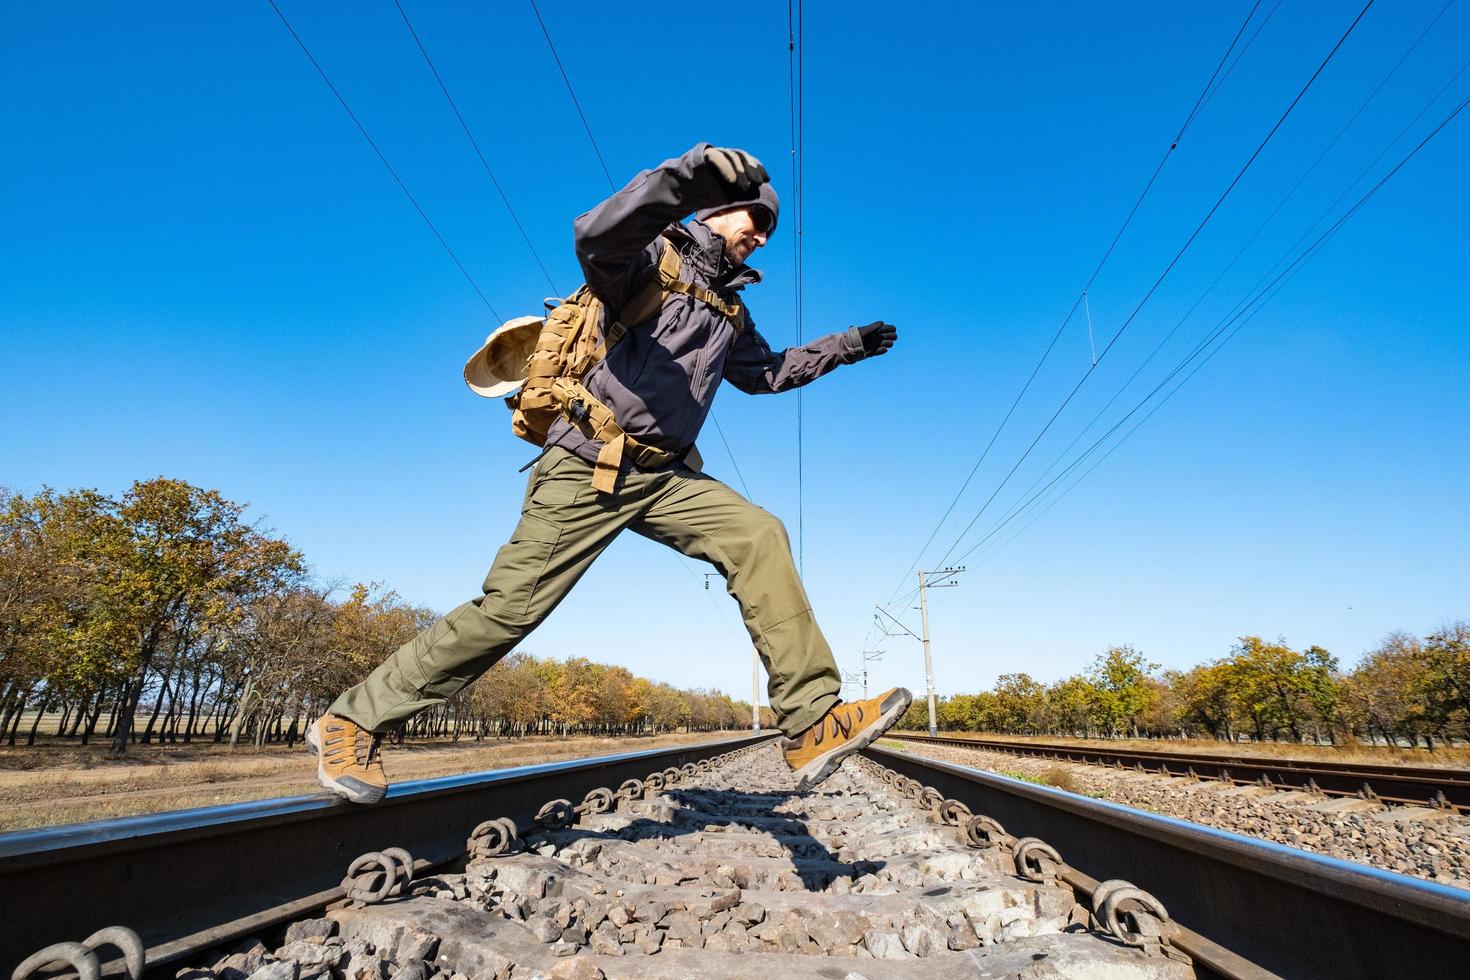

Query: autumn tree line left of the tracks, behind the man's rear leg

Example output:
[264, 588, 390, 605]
[0, 478, 750, 752]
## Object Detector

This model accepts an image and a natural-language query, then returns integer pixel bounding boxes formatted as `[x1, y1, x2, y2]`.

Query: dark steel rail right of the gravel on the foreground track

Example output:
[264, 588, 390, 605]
[864, 745, 1470, 979]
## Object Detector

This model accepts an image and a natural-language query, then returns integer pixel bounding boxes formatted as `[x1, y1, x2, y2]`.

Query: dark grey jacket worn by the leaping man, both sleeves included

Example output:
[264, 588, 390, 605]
[547, 143, 863, 469]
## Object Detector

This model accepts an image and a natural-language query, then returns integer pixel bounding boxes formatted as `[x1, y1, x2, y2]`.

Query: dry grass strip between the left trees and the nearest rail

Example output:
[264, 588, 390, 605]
[0, 732, 741, 830]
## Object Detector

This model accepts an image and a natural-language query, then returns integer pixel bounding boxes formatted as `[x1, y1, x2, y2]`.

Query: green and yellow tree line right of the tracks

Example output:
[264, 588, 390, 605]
[900, 621, 1470, 749]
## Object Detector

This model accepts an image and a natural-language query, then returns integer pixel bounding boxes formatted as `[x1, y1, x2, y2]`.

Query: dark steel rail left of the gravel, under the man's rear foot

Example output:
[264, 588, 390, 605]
[0, 735, 770, 974]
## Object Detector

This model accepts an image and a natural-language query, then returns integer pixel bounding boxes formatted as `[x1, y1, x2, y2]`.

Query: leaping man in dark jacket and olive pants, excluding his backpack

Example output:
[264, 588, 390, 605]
[307, 144, 913, 804]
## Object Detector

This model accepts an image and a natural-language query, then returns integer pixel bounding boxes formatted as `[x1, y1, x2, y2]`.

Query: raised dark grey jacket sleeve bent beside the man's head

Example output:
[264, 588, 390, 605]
[572, 143, 732, 309]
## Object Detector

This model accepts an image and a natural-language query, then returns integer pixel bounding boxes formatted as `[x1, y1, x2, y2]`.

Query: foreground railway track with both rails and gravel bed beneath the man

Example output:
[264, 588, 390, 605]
[0, 739, 1470, 980]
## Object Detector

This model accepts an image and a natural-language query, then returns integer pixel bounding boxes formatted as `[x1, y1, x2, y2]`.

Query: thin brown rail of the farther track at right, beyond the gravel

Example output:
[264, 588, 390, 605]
[885, 732, 1470, 810]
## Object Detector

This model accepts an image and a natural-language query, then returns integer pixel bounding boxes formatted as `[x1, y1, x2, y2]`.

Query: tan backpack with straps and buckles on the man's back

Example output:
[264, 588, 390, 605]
[506, 238, 745, 494]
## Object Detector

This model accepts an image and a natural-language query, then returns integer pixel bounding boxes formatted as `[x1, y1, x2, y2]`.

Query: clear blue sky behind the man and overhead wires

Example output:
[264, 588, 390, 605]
[0, 0, 1470, 696]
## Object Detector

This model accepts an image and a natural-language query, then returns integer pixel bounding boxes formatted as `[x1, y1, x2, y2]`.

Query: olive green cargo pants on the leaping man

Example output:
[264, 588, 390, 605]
[331, 448, 842, 735]
